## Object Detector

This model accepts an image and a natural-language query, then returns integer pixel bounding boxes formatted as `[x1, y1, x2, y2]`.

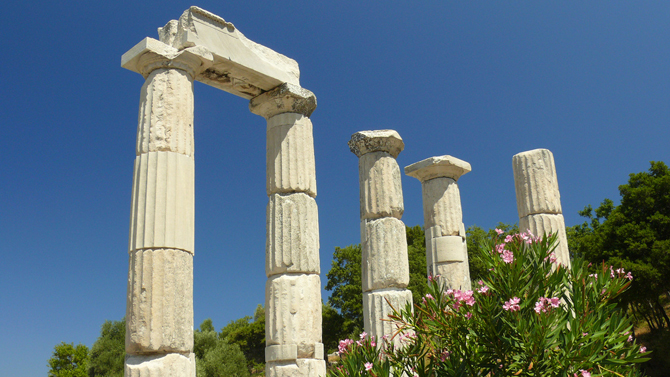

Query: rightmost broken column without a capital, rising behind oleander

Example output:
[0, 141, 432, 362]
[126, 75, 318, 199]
[512, 149, 570, 268]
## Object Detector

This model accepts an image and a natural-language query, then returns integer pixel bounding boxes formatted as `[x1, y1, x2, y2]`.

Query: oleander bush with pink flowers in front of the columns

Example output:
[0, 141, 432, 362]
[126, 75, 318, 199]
[331, 229, 648, 377]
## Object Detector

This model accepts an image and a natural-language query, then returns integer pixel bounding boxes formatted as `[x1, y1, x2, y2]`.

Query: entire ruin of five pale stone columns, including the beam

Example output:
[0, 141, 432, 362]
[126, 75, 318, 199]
[121, 7, 570, 377]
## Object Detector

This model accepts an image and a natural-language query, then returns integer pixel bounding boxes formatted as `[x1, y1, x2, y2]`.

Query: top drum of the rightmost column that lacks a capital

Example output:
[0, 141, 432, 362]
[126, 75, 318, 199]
[512, 149, 562, 218]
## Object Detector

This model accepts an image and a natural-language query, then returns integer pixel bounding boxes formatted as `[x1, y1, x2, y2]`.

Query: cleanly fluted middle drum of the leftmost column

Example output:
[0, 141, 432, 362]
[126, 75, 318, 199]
[129, 152, 195, 253]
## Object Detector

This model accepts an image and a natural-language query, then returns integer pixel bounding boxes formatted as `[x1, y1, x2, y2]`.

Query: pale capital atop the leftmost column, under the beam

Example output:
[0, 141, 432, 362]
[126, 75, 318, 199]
[121, 38, 213, 79]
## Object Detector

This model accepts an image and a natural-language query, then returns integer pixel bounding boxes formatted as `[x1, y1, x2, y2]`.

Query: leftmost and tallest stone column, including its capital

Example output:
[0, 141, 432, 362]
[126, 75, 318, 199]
[124, 41, 211, 377]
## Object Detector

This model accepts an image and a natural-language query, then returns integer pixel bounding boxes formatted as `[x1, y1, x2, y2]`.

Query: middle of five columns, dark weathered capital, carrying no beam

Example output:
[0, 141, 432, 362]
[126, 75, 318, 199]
[349, 130, 412, 341]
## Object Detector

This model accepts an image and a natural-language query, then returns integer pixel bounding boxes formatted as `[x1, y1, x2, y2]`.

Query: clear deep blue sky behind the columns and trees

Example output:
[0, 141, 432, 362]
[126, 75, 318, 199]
[0, 1, 670, 376]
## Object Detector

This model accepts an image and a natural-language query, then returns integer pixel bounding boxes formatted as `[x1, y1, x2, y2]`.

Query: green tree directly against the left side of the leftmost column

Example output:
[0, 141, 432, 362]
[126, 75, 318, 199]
[88, 318, 126, 377]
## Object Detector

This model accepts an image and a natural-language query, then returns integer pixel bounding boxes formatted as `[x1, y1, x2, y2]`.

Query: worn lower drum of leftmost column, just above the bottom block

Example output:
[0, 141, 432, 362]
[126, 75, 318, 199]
[126, 249, 193, 354]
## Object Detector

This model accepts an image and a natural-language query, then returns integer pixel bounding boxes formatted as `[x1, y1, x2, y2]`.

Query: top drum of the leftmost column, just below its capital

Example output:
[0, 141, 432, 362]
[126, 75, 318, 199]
[137, 69, 193, 156]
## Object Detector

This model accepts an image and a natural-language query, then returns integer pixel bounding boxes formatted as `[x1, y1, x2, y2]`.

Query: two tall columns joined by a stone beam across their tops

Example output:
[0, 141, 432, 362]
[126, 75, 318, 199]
[121, 7, 326, 377]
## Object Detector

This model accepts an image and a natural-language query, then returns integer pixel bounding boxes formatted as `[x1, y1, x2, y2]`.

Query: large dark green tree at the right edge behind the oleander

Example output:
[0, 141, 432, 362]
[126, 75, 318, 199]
[568, 161, 670, 329]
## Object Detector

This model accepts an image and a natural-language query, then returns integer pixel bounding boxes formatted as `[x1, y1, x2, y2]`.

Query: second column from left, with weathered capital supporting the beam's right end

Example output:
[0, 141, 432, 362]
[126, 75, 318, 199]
[249, 84, 326, 377]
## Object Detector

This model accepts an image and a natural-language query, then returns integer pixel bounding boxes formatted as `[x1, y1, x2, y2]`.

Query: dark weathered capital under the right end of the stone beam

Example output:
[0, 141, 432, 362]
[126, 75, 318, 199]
[249, 83, 316, 119]
